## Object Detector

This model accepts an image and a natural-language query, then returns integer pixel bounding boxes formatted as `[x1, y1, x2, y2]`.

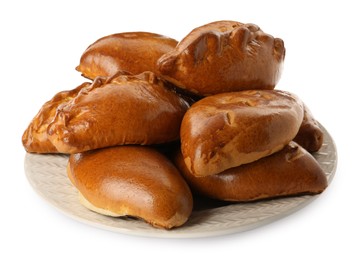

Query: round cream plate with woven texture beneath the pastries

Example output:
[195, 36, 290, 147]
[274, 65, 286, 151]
[25, 126, 337, 238]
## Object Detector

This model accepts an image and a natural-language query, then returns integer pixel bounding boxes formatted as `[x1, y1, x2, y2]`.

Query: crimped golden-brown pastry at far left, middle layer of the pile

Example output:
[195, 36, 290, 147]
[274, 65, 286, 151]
[24, 72, 189, 153]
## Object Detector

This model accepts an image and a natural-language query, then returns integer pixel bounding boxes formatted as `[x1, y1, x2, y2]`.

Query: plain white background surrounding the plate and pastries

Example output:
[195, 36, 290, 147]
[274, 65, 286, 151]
[0, 0, 355, 259]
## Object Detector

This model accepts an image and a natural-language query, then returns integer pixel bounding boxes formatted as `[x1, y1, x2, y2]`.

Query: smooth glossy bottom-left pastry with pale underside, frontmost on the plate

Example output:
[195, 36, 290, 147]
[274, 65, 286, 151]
[67, 146, 192, 229]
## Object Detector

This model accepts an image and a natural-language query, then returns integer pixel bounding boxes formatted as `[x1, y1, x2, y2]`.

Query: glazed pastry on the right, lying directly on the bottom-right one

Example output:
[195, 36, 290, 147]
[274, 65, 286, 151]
[180, 90, 303, 176]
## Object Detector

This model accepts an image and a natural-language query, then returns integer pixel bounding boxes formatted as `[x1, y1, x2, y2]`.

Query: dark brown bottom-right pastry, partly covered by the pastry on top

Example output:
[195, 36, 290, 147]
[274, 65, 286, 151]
[175, 142, 327, 202]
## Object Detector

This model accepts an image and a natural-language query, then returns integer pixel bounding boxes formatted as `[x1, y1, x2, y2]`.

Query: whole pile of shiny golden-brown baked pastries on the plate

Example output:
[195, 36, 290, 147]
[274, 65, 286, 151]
[22, 21, 327, 229]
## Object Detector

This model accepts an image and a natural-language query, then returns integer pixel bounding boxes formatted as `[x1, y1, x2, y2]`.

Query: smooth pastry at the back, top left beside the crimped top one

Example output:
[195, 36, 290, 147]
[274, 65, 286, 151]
[76, 32, 177, 79]
